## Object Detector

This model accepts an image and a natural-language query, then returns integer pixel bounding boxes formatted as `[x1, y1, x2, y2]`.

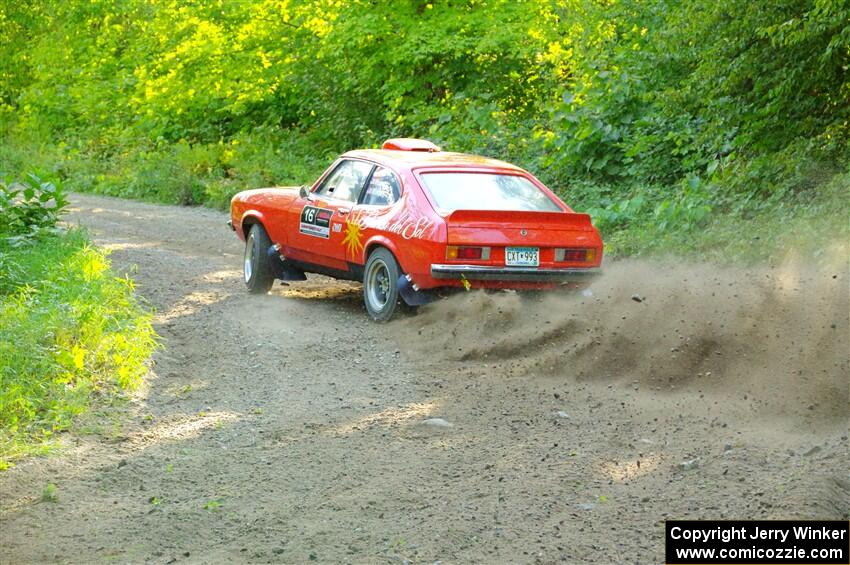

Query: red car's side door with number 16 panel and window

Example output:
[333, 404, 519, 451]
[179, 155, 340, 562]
[292, 159, 374, 270]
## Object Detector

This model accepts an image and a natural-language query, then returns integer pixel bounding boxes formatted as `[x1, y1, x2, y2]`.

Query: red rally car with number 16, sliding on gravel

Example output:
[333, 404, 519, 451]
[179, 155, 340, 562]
[228, 139, 602, 321]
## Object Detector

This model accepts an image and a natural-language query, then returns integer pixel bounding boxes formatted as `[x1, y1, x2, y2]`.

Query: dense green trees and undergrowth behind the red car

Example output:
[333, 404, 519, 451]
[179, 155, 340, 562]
[0, 0, 850, 259]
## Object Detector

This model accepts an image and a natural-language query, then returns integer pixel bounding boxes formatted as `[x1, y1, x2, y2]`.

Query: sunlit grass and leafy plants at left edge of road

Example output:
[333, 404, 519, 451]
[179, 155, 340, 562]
[0, 176, 155, 464]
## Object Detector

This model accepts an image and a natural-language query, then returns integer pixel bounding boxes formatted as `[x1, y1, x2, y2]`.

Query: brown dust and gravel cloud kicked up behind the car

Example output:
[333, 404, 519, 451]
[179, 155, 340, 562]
[395, 247, 850, 427]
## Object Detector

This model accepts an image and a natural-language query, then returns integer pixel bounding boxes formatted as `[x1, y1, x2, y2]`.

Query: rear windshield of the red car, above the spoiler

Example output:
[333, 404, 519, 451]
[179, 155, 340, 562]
[422, 173, 561, 212]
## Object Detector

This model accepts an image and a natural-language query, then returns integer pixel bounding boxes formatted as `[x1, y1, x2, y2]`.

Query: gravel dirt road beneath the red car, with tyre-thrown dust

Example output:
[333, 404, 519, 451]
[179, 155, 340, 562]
[0, 196, 850, 564]
